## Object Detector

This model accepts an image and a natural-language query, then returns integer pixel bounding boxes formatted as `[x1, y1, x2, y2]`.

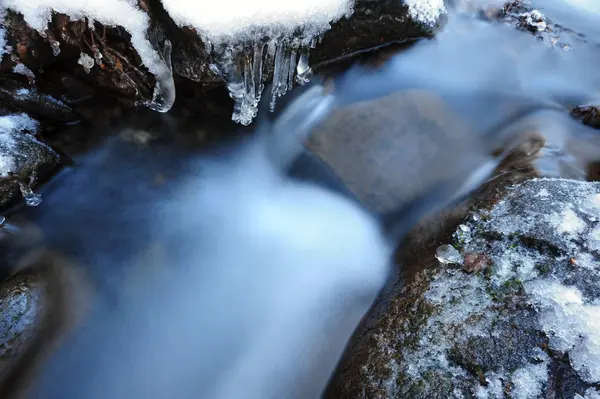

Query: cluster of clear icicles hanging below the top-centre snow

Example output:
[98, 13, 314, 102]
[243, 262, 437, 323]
[209, 35, 317, 125]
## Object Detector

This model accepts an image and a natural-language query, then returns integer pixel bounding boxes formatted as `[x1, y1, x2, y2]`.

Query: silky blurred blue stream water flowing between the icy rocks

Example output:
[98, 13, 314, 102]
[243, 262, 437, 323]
[1, 3, 600, 399]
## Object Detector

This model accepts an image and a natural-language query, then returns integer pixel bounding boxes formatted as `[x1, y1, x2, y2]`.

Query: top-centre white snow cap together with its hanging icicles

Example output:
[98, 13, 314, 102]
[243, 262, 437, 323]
[163, 0, 354, 125]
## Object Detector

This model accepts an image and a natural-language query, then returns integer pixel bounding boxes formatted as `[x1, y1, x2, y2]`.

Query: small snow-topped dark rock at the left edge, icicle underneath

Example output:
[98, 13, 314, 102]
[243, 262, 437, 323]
[0, 114, 59, 207]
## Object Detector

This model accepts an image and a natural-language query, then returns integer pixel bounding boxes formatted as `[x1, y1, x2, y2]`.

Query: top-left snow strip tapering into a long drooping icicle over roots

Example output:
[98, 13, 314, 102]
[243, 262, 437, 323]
[0, 0, 175, 112]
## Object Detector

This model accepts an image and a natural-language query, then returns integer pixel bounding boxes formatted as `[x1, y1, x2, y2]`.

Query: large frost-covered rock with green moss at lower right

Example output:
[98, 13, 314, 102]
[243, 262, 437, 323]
[328, 179, 600, 398]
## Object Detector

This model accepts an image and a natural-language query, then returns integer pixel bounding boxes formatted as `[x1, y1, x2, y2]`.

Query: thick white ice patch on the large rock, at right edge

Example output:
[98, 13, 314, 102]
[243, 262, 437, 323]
[525, 279, 600, 383]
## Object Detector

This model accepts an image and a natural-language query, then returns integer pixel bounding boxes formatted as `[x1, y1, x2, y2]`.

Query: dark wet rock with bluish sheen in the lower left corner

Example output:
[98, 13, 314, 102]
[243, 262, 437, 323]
[0, 250, 89, 399]
